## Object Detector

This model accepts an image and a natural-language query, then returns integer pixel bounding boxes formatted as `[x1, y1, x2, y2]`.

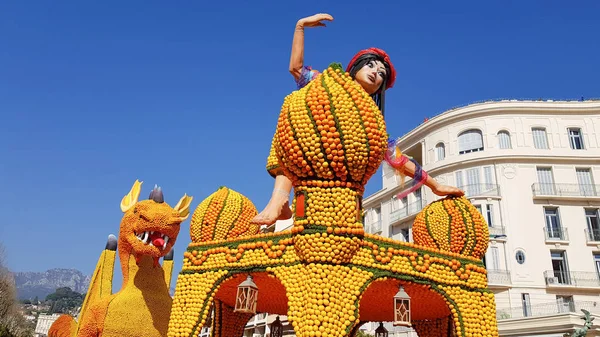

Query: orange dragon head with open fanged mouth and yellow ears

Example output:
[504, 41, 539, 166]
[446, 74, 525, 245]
[119, 180, 193, 264]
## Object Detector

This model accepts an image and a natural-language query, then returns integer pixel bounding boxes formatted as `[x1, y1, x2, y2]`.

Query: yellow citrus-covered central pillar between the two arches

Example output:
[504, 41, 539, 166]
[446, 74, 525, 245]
[268, 263, 373, 337]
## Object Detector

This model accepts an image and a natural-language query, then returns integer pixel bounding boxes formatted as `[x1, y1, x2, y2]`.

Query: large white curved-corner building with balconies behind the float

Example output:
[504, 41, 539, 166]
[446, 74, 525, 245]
[363, 100, 600, 337]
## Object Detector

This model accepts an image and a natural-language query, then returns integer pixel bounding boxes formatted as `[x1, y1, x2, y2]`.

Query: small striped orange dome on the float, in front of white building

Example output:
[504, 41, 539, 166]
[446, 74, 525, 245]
[413, 196, 489, 259]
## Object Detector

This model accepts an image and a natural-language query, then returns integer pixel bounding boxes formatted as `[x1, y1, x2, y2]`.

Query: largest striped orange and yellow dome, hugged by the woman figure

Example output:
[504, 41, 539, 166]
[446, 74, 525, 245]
[271, 64, 387, 186]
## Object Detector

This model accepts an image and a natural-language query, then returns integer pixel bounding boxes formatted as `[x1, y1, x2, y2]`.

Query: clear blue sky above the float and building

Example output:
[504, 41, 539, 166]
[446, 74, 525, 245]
[0, 0, 600, 288]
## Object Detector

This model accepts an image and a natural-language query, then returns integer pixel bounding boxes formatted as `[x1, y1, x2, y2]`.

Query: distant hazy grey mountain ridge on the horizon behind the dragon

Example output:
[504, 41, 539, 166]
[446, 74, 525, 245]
[13, 268, 91, 300]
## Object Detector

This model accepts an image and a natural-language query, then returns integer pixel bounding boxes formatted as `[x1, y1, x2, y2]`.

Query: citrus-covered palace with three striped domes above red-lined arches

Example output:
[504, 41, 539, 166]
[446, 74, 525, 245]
[168, 64, 498, 337]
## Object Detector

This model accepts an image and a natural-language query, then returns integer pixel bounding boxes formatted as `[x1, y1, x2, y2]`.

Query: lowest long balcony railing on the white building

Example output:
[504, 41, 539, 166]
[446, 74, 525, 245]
[496, 301, 600, 320]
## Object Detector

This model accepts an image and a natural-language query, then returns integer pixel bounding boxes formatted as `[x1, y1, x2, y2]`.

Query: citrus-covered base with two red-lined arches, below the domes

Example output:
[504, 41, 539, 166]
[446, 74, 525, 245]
[168, 230, 498, 337]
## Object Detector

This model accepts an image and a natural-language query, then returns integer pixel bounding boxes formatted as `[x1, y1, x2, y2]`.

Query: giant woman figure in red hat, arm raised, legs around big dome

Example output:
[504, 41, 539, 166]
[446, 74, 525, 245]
[252, 14, 464, 225]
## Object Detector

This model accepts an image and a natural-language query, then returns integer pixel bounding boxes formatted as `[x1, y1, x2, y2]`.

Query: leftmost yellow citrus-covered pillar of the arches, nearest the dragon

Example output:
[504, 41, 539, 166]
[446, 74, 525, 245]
[167, 270, 228, 337]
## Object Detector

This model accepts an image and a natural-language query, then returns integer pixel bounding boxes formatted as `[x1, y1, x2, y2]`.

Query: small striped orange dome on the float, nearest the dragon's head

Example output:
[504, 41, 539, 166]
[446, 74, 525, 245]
[190, 186, 259, 242]
